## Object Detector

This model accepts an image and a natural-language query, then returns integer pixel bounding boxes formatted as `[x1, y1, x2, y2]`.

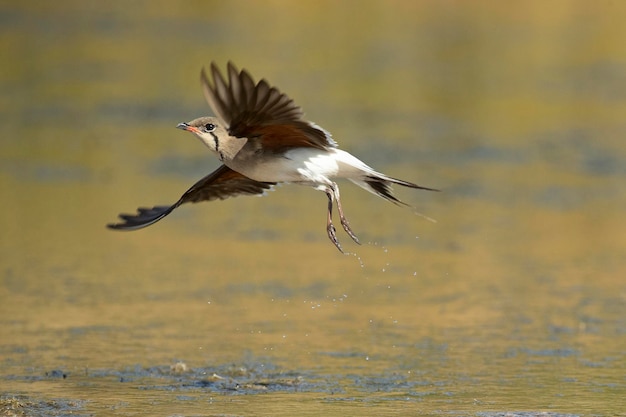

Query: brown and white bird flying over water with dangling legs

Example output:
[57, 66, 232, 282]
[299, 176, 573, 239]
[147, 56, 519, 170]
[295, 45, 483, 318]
[107, 61, 439, 253]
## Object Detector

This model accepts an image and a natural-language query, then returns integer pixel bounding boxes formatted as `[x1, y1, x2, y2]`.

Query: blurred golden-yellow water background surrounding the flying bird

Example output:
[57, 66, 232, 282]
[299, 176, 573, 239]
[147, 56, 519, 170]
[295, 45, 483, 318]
[0, 1, 626, 415]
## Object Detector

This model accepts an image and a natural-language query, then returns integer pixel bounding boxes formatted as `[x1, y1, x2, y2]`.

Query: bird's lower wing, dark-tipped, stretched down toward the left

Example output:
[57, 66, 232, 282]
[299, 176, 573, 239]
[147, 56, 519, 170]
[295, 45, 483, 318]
[107, 165, 275, 230]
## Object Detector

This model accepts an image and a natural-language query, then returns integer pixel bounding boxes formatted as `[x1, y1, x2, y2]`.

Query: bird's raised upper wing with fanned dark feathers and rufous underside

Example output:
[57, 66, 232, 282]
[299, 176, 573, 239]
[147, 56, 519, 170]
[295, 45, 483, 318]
[200, 62, 337, 150]
